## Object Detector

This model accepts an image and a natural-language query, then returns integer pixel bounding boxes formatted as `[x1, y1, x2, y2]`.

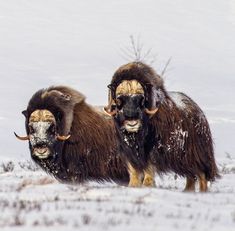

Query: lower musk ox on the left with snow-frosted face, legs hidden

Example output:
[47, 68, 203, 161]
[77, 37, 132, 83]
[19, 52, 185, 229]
[16, 86, 129, 184]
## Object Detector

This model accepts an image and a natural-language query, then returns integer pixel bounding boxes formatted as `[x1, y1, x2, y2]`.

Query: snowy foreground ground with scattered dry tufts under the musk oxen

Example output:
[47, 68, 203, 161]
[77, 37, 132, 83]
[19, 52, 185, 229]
[0, 157, 235, 231]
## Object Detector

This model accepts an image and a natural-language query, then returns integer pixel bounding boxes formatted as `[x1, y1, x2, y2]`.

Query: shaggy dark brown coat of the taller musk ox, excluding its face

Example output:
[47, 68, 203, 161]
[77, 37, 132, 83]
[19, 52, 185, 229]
[106, 62, 219, 191]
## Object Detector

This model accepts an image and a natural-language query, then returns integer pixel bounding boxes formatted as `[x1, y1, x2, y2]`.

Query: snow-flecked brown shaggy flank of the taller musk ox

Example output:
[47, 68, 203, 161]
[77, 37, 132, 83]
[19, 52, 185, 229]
[149, 92, 218, 181]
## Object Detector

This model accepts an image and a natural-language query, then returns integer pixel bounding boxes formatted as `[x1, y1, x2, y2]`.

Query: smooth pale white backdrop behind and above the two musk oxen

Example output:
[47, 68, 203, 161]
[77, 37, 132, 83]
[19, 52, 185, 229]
[0, 0, 235, 158]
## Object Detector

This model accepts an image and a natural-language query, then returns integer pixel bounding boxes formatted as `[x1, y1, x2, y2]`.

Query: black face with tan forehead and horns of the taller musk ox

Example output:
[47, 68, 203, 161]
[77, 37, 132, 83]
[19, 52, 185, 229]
[105, 79, 158, 133]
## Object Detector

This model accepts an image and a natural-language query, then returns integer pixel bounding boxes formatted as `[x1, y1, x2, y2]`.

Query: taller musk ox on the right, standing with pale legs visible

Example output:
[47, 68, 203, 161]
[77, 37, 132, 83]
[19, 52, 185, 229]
[105, 62, 219, 191]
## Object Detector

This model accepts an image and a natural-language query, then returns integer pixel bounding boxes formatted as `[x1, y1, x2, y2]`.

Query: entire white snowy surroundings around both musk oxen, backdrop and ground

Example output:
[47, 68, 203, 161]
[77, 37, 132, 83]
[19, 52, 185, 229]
[0, 0, 235, 231]
